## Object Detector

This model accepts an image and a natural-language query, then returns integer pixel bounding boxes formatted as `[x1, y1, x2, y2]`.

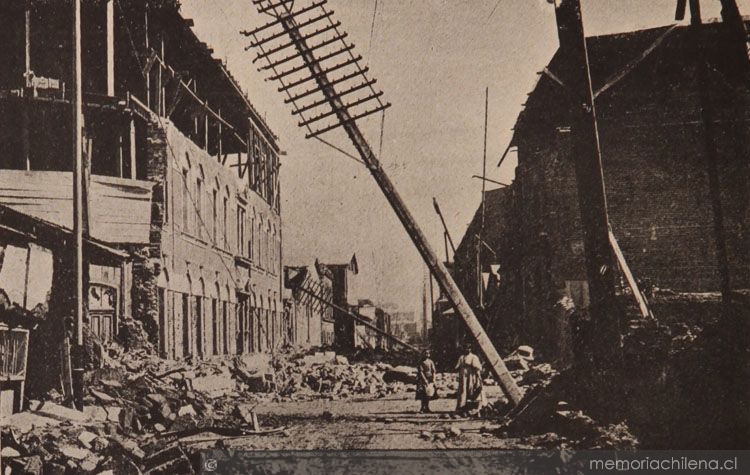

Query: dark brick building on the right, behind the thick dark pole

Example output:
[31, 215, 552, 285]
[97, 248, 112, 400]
[455, 22, 750, 365]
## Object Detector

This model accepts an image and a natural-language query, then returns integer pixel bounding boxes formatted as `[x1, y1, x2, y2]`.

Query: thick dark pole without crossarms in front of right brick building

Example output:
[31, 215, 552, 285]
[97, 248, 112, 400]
[555, 0, 621, 367]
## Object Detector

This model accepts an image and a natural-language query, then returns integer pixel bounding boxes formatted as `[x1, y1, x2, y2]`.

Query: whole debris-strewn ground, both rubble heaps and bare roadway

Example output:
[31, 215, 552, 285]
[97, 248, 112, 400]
[2, 347, 634, 474]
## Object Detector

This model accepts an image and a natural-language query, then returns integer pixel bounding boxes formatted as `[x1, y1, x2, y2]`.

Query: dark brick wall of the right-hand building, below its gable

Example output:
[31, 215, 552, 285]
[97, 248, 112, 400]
[506, 85, 750, 362]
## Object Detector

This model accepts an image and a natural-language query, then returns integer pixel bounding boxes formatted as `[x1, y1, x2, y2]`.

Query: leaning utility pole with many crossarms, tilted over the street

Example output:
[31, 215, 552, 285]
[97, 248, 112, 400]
[244, 0, 523, 405]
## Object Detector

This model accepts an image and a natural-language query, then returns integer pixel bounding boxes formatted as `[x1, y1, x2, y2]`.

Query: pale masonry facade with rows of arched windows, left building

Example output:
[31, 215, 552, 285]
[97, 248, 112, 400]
[140, 119, 286, 358]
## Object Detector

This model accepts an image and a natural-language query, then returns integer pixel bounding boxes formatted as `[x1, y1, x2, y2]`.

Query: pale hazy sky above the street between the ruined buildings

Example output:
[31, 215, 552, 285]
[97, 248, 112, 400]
[182, 0, 750, 310]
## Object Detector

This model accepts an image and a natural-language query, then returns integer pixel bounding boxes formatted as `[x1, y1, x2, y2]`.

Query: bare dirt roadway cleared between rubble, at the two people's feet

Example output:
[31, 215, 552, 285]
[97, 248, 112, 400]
[185, 386, 512, 450]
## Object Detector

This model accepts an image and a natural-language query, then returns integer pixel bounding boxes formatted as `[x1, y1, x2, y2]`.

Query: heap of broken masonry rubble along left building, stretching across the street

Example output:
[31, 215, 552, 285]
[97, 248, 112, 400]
[2, 345, 434, 474]
